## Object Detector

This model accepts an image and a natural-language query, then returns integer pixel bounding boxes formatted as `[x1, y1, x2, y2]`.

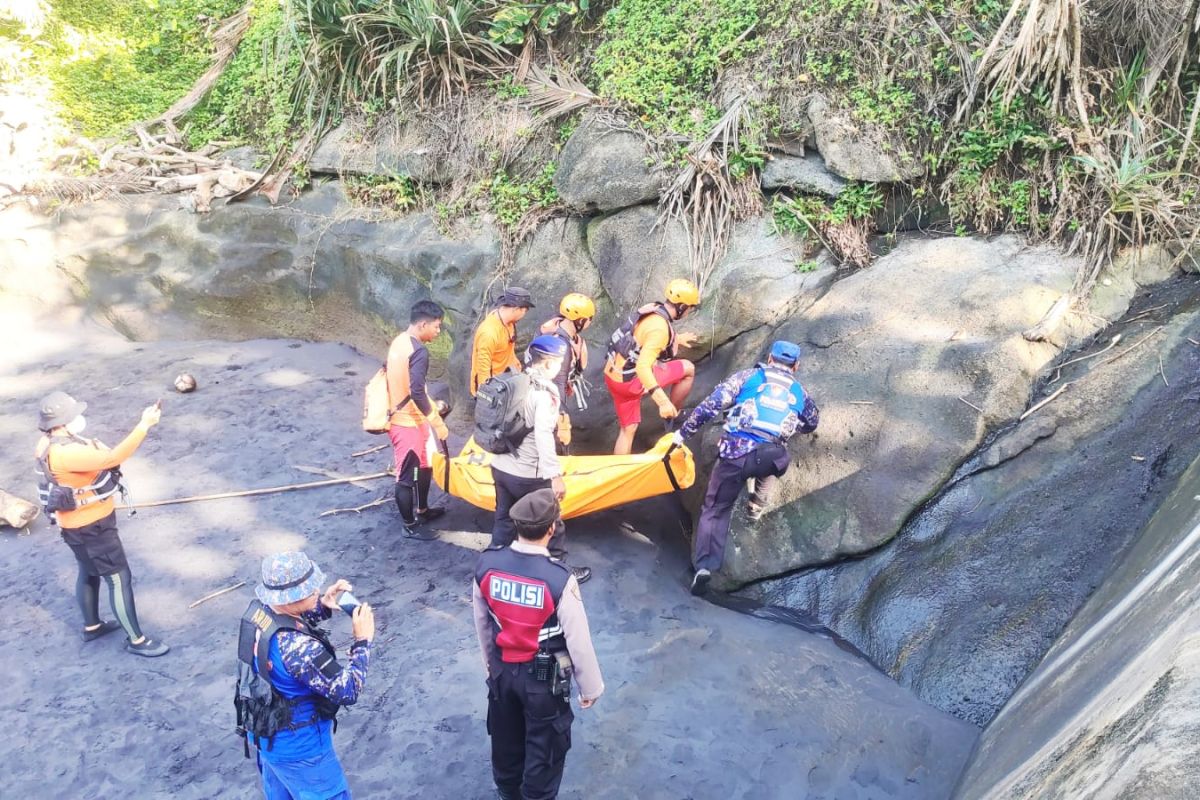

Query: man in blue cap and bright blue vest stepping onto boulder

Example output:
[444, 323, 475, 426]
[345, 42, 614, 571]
[676, 341, 820, 595]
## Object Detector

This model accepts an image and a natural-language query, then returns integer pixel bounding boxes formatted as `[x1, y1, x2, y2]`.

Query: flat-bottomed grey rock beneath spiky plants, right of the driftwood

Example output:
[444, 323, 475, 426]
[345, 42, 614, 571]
[308, 119, 463, 184]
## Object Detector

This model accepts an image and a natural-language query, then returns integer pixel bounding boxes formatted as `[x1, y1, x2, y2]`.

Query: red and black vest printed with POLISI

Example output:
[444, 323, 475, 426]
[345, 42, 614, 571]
[475, 547, 571, 663]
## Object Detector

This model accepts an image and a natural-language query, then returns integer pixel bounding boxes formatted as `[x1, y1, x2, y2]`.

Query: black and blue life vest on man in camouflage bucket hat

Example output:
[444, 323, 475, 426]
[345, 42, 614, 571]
[233, 600, 342, 758]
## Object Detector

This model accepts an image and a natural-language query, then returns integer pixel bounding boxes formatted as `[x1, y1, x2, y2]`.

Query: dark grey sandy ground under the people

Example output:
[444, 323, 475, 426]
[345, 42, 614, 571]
[0, 308, 977, 800]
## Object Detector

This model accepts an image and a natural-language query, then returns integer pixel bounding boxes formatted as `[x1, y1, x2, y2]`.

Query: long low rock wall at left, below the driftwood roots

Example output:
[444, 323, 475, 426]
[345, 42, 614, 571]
[0, 185, 499, 364]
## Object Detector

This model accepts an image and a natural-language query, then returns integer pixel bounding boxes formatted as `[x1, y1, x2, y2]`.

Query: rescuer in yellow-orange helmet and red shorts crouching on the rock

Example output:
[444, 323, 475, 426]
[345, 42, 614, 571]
[604, 278, 700, 456]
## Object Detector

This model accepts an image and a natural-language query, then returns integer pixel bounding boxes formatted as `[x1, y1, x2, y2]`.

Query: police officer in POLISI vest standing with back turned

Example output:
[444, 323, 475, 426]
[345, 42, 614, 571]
[472, 488, 604, 800]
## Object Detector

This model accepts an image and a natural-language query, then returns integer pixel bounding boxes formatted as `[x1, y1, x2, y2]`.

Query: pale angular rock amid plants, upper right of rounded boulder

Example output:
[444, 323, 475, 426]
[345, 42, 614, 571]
[809, 95, 925, 184]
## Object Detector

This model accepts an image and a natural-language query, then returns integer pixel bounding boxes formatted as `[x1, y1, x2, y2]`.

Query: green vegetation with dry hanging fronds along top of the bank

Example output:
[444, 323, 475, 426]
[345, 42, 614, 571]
[11, 0, 1200, 284]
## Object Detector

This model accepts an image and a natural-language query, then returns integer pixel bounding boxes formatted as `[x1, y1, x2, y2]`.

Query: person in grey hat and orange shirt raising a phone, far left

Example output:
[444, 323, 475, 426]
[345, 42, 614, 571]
[35, 392, 170, 658]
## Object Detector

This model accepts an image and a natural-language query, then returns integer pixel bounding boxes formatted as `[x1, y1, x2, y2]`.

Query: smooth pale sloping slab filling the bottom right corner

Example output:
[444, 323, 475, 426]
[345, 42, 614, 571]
[954, 448, 1200, 800]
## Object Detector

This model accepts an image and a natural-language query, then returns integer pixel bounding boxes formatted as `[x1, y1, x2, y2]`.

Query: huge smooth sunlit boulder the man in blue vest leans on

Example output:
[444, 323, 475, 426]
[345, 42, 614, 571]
[724, 237, 1123, 583]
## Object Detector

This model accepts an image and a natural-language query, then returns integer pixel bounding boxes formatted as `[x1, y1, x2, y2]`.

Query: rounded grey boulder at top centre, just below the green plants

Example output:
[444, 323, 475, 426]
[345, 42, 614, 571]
[554, 119, 668, 212]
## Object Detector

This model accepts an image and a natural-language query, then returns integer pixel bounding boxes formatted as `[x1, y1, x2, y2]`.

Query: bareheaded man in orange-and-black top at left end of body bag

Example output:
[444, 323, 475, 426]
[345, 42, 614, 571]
[388, 300, 450, 540]
